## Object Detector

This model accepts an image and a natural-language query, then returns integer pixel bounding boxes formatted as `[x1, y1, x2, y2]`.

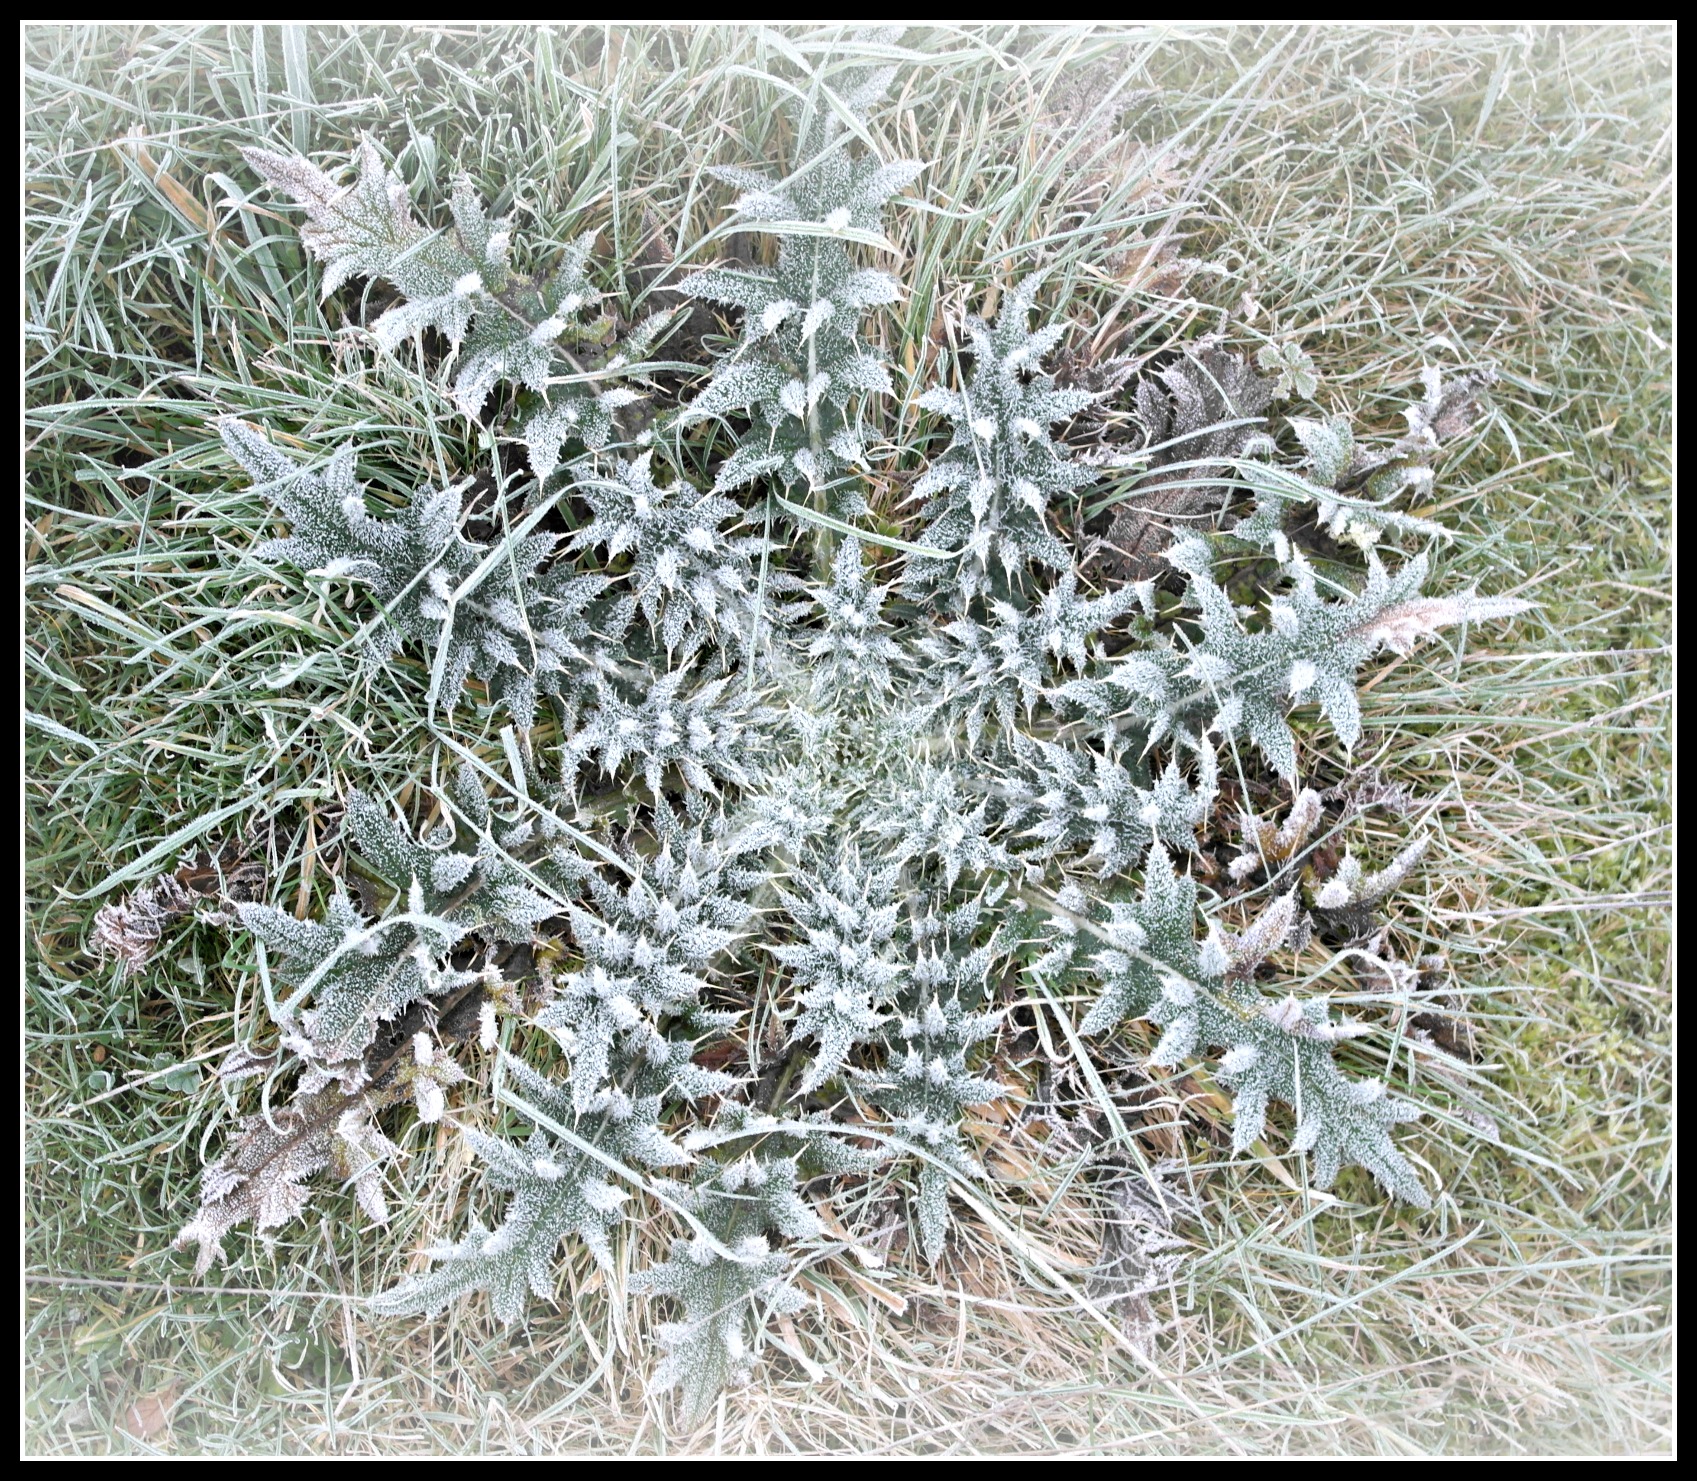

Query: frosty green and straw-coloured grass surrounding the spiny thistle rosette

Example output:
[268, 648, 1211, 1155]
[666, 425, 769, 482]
[24, 27, 1672, 1454]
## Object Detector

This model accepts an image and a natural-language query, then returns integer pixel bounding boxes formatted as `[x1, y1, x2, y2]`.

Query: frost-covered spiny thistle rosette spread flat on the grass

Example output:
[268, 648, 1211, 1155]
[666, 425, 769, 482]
[89, 51, 1526, 1423]
